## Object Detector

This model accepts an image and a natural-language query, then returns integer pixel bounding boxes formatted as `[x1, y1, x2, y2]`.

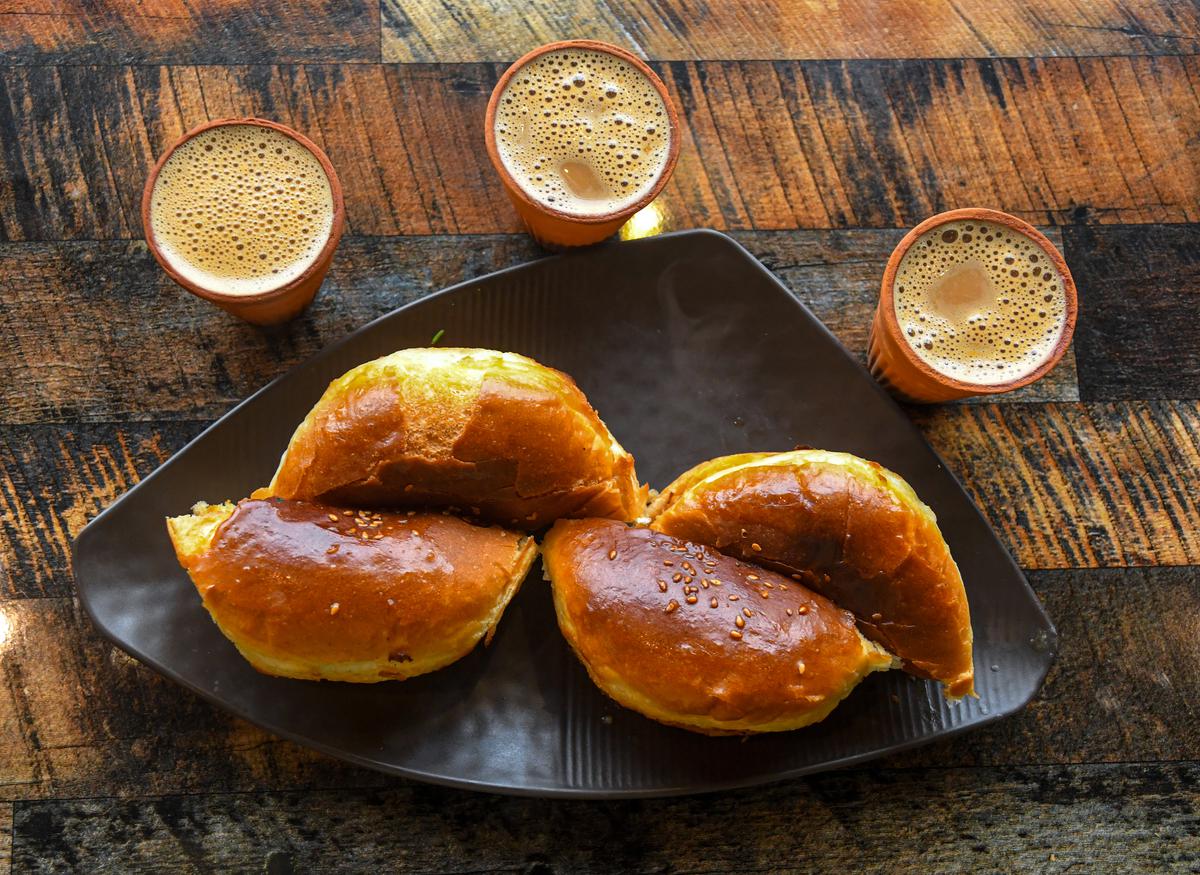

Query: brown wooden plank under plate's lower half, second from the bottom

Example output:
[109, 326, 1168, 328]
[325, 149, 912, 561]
[0, 568, 1200, 799]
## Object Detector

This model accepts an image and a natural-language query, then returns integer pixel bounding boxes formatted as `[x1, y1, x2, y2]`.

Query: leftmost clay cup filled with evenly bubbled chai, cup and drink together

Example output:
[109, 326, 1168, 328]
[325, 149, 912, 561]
[142, 119, 343, 324]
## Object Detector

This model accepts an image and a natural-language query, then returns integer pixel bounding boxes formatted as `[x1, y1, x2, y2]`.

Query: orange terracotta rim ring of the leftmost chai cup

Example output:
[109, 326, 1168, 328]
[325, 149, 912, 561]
[142, 116, 346, 305]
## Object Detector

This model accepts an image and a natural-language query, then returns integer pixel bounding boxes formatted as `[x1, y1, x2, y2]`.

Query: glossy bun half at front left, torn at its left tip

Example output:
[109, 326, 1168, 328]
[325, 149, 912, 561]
[167, 499, 538, 683]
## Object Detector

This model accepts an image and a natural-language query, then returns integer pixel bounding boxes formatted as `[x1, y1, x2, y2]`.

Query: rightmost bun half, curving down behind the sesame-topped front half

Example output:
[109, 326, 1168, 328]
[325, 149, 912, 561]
[652, 450, 974, 697]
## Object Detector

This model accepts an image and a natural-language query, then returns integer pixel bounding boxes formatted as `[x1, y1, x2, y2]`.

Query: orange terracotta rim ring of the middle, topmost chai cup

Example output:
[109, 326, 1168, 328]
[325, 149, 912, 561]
[484, 40, 679, 224]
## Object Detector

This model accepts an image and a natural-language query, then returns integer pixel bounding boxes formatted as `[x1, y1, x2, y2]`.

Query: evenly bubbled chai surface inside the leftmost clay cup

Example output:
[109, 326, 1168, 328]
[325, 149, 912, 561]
[150, 125, 334, 294]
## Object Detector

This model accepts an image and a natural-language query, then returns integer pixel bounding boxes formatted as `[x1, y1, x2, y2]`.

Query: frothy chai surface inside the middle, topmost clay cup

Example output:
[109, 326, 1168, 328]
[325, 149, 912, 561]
[494, 49, 671, 216]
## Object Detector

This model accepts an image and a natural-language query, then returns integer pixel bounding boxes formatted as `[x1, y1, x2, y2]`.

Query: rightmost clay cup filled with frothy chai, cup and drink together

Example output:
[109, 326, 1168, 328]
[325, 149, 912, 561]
[869, 209, 1078, 401]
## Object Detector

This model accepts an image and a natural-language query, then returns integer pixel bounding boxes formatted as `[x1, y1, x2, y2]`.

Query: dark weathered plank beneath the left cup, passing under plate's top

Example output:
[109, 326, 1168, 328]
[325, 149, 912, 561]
[0, 230, 1084, 424]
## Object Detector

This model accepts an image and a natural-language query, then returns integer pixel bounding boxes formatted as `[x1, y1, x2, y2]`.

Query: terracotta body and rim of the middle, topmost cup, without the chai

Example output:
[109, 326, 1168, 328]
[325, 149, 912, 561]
[484, 40, 679, 247]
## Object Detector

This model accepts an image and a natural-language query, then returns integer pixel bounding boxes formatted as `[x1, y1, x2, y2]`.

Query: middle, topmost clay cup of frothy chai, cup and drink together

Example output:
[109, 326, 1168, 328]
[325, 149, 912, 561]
[485, 40, 679, 246]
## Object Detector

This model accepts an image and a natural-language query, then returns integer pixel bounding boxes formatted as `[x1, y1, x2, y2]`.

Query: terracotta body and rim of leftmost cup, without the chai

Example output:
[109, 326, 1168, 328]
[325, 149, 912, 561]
[142, 119, 346, 325]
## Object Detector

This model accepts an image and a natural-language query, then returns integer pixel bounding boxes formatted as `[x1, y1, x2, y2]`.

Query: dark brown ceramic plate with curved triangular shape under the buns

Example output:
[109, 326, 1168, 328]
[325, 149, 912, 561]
[74, 232, 1055, 797]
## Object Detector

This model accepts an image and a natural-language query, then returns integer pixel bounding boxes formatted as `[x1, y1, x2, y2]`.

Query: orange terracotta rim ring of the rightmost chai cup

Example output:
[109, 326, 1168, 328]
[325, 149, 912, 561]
[878, 206, 1079, 395]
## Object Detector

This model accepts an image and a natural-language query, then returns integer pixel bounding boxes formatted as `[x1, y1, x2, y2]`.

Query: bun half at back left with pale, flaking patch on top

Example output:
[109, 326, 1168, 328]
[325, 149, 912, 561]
[269, 348, 646, 531]
